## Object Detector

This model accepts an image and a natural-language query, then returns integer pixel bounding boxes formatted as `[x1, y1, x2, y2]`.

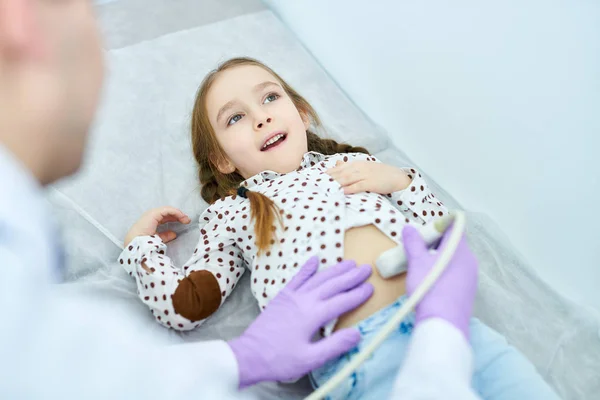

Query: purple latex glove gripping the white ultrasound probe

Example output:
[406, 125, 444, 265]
[402, 225, 478, 340]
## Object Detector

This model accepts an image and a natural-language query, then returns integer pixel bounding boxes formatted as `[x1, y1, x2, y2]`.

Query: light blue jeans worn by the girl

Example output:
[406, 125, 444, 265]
[311, 297, 558, 400]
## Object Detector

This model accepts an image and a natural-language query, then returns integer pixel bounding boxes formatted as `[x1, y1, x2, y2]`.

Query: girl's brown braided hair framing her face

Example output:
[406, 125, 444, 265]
[191, 57, 369, 253]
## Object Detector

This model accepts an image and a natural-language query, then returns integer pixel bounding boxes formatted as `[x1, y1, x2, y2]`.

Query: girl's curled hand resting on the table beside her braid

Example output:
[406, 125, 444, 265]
[125, 207, 191, 247]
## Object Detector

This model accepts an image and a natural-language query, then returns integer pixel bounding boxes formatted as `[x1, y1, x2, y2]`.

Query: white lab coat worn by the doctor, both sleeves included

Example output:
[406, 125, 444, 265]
[0, 144, 473, 399]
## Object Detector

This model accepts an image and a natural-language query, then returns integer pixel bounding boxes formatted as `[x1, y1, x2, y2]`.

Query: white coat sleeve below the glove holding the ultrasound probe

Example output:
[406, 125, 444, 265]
[390, 318, 479, 400]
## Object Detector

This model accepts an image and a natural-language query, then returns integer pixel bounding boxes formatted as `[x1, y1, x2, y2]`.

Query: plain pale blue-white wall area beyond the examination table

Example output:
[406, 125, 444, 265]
[267, 0, 600, 307]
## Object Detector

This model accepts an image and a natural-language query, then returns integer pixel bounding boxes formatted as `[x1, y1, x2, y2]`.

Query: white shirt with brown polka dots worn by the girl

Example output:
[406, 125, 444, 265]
[119, 152, 447, 333]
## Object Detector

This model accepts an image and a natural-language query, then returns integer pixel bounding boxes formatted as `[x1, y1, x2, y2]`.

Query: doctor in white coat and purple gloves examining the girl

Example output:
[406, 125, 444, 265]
[0, 0, 476, 399]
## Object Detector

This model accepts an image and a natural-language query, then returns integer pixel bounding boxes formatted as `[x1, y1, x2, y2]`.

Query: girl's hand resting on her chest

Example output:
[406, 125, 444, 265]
[327, 161, 412, 194]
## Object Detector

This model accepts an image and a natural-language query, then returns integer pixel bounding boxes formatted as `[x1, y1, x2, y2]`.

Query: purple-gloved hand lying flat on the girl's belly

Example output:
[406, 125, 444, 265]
[229, 257, 373, 388]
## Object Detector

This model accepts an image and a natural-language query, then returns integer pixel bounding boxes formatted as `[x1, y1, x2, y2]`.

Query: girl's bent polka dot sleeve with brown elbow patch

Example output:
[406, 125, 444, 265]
[119, 200, 245, 330]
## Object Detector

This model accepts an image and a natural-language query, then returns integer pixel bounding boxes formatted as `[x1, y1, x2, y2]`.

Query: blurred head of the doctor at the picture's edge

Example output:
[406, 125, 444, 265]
[0, 0, 103, 184]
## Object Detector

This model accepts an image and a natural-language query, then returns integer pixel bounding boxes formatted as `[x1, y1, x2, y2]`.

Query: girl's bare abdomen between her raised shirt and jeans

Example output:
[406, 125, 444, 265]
[335, 225, 406, 330]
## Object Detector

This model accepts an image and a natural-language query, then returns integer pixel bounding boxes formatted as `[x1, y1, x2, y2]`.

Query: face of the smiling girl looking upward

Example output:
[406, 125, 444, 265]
[206, 65, 309, 179]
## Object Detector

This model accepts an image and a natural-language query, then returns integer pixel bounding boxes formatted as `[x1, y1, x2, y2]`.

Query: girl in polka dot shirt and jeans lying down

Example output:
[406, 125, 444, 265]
[119, 58, 551, 399]
